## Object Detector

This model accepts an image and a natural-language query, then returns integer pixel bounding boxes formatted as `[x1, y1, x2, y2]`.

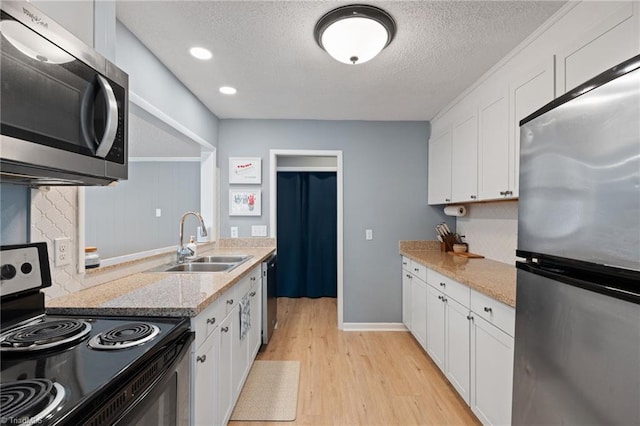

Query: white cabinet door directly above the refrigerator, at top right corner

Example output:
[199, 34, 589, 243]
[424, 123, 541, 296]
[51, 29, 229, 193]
[557, 2, 640, 95]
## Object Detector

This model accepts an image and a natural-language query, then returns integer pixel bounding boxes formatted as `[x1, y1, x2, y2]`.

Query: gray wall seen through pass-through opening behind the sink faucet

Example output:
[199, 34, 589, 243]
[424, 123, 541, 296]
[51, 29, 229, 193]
[85, 162, 200, 259]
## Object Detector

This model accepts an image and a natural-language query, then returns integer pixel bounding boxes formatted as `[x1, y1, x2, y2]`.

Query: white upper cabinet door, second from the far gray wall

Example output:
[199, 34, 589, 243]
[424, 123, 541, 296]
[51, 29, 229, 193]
[451, 108, 478, 203]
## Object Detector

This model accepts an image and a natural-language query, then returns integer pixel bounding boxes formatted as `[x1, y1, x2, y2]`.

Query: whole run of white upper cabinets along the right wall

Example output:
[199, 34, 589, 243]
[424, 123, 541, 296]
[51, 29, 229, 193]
[428, 1, 640, 204]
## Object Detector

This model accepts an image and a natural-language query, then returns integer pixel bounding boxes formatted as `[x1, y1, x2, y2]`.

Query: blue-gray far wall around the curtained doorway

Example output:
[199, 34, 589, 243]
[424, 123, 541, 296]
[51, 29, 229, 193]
[218, 119, 454, 322]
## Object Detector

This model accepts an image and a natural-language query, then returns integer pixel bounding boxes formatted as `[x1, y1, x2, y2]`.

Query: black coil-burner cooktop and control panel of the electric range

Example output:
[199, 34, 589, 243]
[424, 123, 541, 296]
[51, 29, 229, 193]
[0, 243, 193, 425]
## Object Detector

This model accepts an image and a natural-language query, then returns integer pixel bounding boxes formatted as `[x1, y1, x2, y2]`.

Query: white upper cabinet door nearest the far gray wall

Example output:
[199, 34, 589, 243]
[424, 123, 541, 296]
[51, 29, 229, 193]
[427, 130, 451, 204]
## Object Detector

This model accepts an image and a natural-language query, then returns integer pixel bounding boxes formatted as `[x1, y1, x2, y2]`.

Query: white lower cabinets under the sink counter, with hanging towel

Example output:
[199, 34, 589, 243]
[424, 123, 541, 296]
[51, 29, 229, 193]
[192, 266, 262, 426]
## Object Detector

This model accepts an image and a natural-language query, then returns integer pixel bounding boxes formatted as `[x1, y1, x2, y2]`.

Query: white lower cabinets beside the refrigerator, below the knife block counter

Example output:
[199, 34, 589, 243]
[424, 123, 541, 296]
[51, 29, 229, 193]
[402, 266, 515, 425]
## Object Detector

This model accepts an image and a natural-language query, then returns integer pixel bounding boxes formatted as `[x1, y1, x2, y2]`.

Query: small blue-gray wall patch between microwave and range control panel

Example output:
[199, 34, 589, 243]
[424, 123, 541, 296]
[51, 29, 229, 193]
[0, 183, 31, 244]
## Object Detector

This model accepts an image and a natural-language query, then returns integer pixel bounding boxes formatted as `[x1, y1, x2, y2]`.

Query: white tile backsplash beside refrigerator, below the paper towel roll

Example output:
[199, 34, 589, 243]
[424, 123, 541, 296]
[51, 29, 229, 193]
[456, 201, 518, 265]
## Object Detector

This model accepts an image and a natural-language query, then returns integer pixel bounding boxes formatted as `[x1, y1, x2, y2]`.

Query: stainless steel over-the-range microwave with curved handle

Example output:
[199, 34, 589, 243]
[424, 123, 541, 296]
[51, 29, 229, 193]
[0, 0, 129, 186]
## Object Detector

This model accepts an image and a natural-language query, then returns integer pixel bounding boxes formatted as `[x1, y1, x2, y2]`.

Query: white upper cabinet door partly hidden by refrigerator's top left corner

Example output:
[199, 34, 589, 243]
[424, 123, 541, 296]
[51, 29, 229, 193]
[507, 56, 555, 197]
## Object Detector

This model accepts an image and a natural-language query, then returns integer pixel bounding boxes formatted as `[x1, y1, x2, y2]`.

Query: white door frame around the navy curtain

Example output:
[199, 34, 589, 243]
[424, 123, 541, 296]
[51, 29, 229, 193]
[269, 149, 344, 330]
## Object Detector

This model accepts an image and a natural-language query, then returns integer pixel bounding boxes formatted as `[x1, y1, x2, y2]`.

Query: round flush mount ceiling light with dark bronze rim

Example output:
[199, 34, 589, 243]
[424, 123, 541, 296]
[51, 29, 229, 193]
[314, 4, 396, 65]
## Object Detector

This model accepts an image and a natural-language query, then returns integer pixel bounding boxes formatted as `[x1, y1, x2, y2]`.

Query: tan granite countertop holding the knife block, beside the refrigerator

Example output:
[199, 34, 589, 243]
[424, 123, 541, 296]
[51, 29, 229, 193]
[400, 241, 516, 308]
